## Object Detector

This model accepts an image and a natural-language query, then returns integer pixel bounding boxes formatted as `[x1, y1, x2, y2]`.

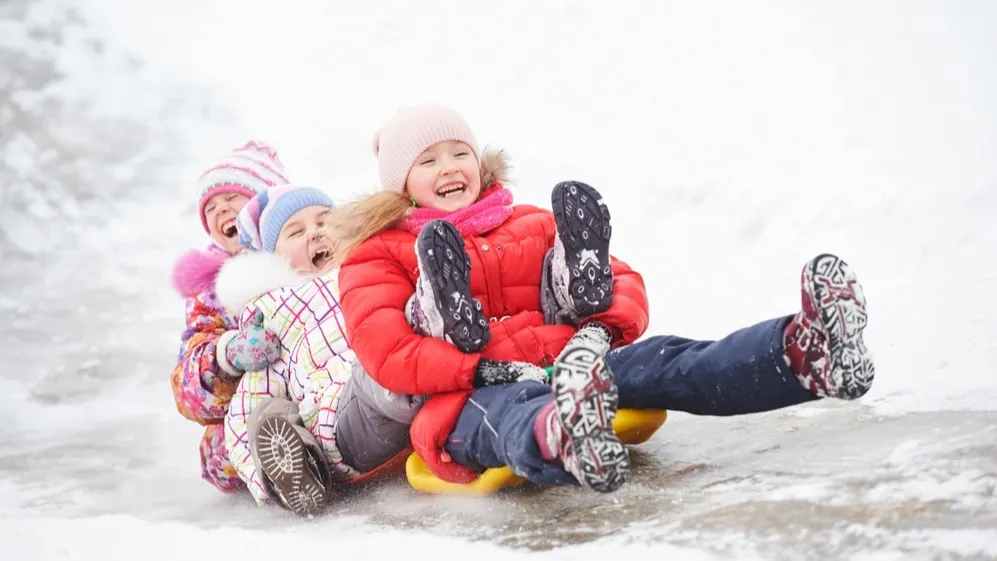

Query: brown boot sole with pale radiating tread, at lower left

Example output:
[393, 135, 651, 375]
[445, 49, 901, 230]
[256, 417, 326, 516]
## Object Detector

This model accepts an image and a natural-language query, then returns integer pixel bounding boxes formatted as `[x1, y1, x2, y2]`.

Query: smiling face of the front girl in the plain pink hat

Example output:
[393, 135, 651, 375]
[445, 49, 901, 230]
[405, 140, 481, 212]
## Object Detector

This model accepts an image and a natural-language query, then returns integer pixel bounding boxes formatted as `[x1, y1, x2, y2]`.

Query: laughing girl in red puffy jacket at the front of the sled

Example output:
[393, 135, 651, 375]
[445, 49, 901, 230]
[337, 105, 873, 491]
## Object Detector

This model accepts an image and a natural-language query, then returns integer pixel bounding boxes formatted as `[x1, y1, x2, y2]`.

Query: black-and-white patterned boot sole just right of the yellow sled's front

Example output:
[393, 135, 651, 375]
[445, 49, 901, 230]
[551, 347, 630, 493]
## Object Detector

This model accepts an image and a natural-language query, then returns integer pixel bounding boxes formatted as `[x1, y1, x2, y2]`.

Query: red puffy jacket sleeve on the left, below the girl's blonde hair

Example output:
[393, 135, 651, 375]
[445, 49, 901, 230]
[339, 237, 479, 395]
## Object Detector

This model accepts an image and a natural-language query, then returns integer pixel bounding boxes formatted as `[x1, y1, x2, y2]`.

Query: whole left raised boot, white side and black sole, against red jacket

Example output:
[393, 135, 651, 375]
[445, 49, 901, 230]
[405, 220, 491, 353]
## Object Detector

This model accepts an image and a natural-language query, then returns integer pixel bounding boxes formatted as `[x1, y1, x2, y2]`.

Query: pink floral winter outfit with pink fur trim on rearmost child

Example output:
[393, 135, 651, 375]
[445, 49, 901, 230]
[170, 245, 245, 492]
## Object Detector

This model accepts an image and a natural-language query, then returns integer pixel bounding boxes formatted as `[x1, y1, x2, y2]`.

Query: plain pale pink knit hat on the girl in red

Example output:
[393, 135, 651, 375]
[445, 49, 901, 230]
[374, 103, 478, 193]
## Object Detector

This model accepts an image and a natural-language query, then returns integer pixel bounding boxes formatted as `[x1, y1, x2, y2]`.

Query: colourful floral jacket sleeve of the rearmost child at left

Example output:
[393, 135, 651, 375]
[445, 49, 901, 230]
[170, 293, 238, 425]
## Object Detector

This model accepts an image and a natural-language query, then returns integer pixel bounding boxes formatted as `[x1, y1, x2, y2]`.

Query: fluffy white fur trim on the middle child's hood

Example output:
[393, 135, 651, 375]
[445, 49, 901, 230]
[215, 251, 308, 317]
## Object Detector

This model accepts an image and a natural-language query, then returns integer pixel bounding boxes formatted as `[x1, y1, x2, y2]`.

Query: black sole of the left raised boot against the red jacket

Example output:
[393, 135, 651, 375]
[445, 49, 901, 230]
[417, 220, 491, 353]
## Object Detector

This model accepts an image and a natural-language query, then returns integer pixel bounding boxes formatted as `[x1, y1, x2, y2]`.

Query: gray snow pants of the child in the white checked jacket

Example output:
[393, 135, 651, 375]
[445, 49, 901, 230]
[336, 361, 426, 473]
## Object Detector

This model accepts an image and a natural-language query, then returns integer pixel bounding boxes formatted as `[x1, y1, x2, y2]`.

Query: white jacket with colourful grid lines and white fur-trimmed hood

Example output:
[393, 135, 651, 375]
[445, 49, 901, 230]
[217, 253, 357, 505]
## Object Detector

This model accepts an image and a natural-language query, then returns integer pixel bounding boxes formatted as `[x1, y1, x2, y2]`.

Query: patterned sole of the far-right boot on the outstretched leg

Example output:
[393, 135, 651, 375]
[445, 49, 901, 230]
[802, 253, 876, 399]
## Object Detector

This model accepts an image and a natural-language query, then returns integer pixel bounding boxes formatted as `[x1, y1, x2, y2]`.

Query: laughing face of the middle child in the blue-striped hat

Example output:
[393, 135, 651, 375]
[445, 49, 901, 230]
[274, 206, 333, 275]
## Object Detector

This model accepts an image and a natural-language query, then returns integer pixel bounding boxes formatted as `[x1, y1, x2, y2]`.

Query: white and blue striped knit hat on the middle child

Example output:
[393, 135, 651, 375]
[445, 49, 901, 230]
[236, 185, 336, 253]
